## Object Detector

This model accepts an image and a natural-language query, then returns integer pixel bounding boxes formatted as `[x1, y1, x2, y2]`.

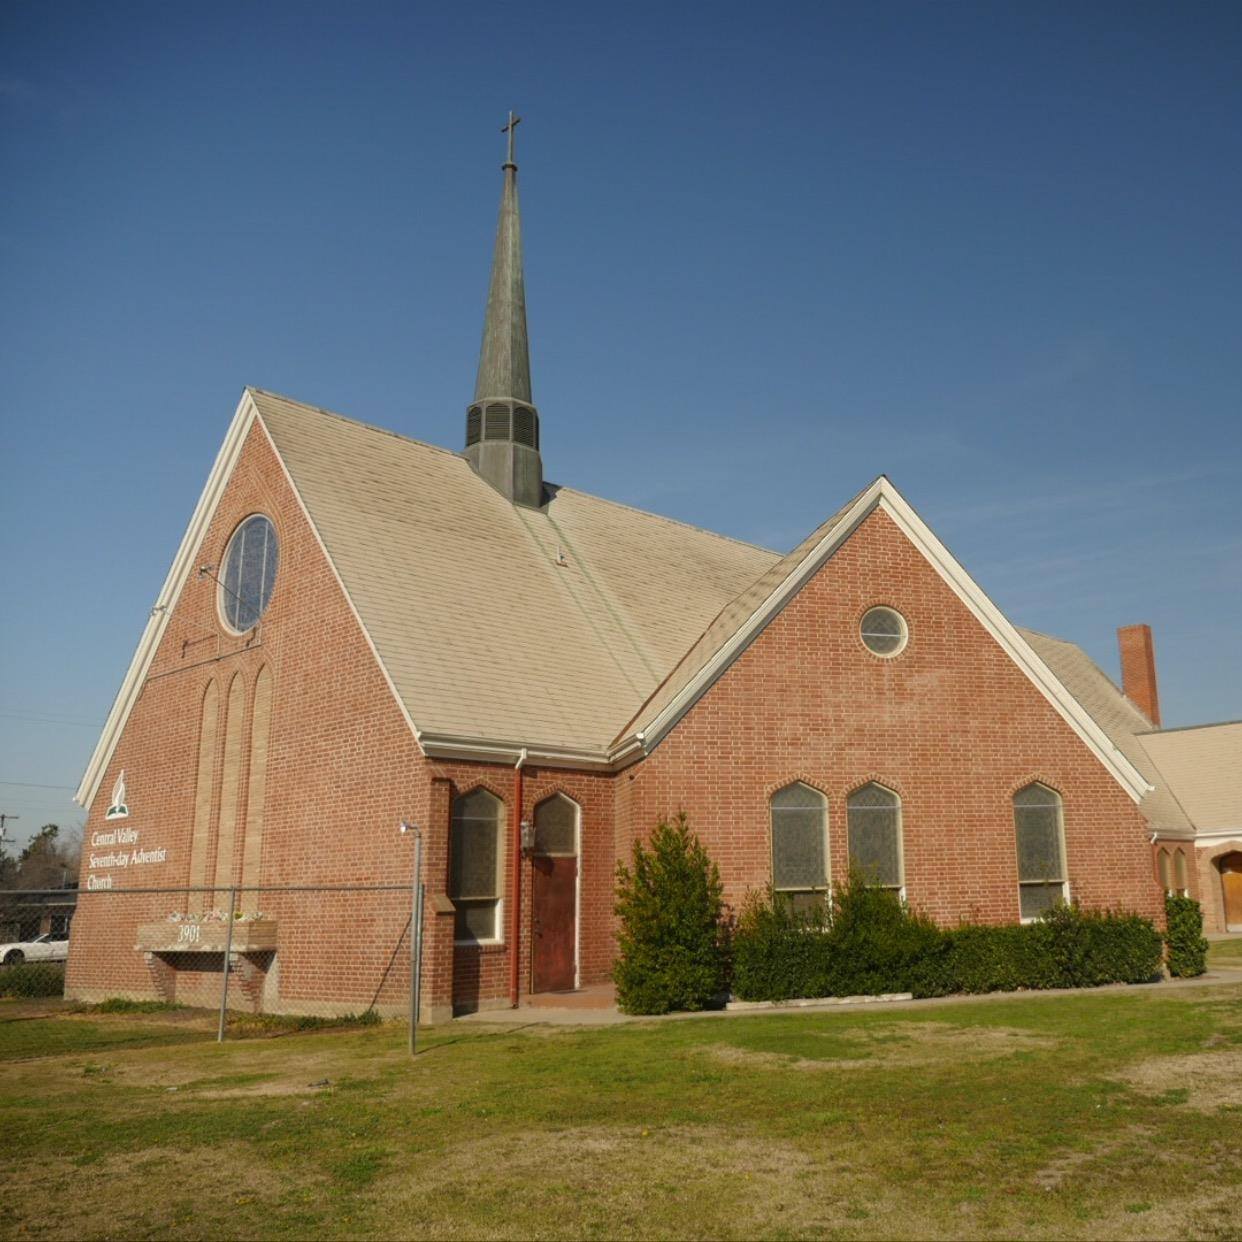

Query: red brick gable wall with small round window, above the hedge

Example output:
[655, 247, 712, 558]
[617, 510, 1160, 923]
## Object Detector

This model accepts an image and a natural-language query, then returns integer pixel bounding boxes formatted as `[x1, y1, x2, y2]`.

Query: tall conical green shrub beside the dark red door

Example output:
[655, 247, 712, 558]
[612, 814, 727, 1013]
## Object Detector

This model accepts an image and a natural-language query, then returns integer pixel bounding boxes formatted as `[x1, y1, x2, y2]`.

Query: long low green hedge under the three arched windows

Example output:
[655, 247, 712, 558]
[733, 879, 1163, 1001]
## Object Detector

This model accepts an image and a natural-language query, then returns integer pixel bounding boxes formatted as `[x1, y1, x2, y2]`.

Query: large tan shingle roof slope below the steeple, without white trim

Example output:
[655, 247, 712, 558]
[248, 389, 779, 758]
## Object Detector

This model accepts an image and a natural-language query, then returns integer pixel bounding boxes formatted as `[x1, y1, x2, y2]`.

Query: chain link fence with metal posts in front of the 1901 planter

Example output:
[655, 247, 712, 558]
[0, 883, 422, 1058]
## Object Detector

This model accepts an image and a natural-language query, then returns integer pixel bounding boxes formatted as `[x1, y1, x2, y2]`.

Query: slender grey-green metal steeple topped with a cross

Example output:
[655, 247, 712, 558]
[466, 112, 543, 508]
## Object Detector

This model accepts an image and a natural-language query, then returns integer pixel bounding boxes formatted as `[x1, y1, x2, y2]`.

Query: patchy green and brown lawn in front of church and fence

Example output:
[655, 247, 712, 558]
[0, 984, 1242, 1238]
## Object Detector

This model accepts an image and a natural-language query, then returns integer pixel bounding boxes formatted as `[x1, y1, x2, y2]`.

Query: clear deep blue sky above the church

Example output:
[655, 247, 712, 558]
[0, 0, 1242, 840]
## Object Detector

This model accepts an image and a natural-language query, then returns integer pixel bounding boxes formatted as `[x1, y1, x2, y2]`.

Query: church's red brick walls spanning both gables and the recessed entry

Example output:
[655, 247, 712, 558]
[68, 447, 1160, 1016]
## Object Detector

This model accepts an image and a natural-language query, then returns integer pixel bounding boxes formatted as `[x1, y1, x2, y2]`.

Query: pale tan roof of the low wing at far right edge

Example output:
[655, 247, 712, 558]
[1139, 720, 1242, 832]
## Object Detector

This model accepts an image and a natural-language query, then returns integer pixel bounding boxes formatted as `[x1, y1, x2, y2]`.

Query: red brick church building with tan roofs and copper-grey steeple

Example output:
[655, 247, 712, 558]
[67, 128, 1242, 1018]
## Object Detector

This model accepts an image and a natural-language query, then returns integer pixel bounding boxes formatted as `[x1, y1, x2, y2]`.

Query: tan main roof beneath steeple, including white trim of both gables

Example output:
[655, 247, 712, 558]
[76, 389, 1150, 805]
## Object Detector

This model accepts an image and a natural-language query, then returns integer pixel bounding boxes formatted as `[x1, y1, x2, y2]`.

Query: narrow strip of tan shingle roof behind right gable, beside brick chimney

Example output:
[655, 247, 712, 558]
[1020, 630, 1194, 832]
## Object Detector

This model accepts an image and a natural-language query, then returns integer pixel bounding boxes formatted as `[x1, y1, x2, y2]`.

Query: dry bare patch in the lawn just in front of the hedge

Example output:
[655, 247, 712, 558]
[703, 1022, 1059, 1071]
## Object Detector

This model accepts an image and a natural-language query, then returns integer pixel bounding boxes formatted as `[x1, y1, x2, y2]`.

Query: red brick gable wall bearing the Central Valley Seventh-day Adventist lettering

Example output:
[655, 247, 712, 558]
[68, 424, 437, 1009]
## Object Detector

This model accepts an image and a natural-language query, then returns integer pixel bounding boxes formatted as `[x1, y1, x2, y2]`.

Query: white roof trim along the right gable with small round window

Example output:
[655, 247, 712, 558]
[614, 477, 1151, 802]
